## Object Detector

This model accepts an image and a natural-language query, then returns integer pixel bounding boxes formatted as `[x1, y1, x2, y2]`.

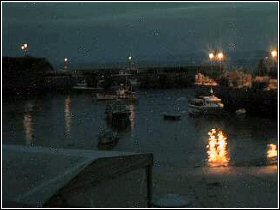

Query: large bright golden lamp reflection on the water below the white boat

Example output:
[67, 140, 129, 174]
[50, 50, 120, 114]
[206, 129, 230, 167]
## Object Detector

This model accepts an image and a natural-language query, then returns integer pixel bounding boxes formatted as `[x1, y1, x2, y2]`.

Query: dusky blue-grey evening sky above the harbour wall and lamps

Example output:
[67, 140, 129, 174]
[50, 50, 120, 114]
[2, 2, 278, 66]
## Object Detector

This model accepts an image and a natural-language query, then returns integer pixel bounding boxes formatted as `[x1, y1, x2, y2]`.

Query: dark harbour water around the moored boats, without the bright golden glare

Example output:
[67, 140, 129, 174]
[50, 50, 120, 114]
[2, 89, 277, 167]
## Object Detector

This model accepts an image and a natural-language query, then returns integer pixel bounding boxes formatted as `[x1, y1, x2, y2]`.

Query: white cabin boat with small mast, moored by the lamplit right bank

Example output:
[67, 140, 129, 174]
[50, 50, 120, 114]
[189, 88, 224, 115]
